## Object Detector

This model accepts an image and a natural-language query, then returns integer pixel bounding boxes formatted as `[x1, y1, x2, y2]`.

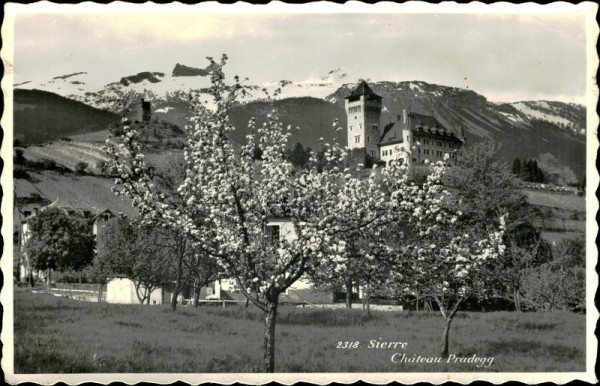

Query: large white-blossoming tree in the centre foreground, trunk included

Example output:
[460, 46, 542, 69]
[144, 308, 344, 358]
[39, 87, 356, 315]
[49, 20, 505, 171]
[105, 56, 382, 372]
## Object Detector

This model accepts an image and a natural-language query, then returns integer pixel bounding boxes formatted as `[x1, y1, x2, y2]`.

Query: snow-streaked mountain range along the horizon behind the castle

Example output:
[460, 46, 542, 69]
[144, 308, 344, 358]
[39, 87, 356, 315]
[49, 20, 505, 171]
[15, 64, 586, 180]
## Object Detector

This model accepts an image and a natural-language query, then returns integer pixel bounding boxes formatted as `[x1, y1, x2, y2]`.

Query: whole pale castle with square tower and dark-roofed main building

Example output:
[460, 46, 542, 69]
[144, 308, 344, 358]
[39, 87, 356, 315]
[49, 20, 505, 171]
[345, 80, 464, 166]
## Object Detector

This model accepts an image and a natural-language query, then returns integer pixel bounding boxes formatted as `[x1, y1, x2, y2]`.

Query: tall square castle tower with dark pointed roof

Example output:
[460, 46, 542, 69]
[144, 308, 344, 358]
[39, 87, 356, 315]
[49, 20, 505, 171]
[345, 80, 382, 159]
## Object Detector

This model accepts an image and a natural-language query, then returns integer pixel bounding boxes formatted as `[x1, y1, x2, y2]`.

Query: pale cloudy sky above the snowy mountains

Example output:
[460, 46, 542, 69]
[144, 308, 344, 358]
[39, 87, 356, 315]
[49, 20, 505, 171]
[14, 6, 586, 103]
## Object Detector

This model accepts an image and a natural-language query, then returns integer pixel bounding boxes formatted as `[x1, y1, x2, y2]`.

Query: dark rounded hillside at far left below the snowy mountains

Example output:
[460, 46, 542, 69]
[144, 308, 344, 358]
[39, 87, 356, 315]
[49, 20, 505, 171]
[14, 89, 119, 144]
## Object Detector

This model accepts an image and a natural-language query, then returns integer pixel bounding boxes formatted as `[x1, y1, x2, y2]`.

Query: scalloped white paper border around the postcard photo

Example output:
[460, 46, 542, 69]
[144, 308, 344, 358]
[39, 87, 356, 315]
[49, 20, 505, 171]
[0, 1, 600, 385]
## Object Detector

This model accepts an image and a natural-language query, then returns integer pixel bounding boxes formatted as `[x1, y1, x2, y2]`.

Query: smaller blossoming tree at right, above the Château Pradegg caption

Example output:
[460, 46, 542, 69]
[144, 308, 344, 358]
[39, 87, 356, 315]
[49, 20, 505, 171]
[382, 157, 505, 356]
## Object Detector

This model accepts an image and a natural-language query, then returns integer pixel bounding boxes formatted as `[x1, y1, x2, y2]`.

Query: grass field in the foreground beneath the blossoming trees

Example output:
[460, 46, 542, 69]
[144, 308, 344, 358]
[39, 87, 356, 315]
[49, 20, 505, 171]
[14, 288, 585, 373]
